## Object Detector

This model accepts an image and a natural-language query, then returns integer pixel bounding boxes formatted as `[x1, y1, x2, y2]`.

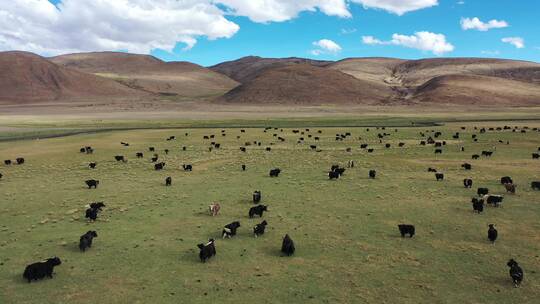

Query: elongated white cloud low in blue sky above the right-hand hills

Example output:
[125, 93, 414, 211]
[362, 31, 454, 56]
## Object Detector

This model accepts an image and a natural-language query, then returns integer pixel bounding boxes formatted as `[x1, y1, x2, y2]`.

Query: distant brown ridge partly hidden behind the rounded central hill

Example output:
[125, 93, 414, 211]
[210, 56, 332, 83]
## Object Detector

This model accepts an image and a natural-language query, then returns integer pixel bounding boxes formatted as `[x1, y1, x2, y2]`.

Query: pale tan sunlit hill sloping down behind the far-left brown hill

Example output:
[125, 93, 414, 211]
[51, 52, 238, 97]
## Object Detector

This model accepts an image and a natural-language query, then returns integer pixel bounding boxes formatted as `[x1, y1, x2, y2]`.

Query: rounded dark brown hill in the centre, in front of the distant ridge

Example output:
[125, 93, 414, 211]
[219, 64, 390, 105]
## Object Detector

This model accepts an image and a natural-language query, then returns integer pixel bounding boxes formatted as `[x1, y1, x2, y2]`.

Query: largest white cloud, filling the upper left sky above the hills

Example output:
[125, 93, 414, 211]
[0, 0, 239, 55]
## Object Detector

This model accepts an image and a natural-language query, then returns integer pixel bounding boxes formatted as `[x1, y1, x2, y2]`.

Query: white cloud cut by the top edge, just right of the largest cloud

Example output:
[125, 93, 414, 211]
[212, 0, 351, 23]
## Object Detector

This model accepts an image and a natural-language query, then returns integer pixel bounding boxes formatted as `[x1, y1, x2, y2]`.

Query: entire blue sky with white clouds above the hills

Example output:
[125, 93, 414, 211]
[0, 0, 540, 66]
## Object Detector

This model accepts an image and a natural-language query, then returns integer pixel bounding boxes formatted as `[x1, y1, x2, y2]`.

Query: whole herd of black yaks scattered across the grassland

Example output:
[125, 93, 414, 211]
[4, 126, 540, 287]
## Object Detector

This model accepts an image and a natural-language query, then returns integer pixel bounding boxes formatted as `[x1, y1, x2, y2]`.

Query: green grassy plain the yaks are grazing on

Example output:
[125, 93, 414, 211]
[0, 119, 540, 303]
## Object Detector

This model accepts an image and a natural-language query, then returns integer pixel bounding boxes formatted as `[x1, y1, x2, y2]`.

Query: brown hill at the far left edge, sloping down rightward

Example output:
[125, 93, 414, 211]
[0, 52, 142, 102]
